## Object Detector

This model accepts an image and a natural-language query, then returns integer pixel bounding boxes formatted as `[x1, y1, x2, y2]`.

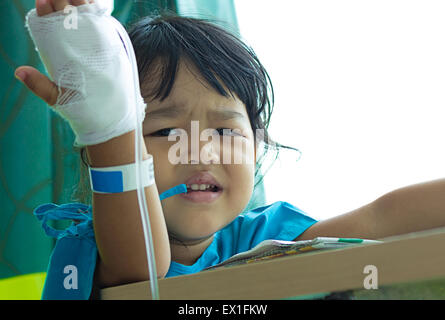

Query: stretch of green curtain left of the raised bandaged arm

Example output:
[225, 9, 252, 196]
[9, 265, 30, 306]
[0, 0, 56, 278]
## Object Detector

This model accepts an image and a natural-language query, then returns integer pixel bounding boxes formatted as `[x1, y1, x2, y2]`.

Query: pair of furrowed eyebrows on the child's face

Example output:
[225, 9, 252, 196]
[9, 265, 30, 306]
[147, 105, 246, 120]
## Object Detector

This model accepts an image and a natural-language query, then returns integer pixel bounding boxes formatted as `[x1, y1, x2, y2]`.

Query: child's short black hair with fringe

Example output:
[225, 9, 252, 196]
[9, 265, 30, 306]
[74, 13, 299, 205]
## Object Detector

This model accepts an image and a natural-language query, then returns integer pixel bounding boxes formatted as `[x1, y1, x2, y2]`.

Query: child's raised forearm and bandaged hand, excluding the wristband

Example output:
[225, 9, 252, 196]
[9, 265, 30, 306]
[16, 0, 170, 287]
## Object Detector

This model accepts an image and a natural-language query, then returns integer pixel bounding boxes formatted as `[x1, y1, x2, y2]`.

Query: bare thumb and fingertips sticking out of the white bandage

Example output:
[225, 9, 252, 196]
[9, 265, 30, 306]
[15, 0, 94, 106]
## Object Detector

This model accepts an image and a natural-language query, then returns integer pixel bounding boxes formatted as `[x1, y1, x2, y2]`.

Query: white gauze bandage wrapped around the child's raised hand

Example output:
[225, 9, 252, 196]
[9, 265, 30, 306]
[26, 3, 146, 147]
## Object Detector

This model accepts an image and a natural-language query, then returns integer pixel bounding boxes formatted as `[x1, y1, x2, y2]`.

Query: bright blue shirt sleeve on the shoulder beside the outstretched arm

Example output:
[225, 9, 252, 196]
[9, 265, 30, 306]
[221, 201, 317, 256]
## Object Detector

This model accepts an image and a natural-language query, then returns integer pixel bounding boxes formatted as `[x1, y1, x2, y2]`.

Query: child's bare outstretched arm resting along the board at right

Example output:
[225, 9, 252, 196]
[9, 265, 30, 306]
[296, 179, 445, 240]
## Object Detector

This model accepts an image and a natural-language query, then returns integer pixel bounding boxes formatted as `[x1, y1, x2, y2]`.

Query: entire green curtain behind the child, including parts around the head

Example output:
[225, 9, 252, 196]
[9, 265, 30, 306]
[0, 0, 264, 278]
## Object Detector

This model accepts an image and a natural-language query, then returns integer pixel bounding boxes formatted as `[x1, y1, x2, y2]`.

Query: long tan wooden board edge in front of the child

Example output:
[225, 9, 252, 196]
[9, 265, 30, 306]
[99, 228, 445, 300]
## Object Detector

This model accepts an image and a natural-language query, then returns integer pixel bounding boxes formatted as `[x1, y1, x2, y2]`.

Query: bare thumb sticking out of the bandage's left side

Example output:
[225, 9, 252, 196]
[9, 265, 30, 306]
[15, 66, 60, 106]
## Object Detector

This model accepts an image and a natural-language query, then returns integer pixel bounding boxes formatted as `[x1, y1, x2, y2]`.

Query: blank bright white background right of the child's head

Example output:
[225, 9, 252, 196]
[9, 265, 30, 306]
[235, 0, 445, 219]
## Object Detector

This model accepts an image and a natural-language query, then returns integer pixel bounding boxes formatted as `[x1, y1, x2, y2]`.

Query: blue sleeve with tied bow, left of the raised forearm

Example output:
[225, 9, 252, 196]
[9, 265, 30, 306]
[34, 203, 97, 300]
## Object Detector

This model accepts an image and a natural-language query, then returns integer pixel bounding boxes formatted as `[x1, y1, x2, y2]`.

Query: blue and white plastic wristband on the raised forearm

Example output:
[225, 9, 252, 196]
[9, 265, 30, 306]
[89, 156, 155, 193]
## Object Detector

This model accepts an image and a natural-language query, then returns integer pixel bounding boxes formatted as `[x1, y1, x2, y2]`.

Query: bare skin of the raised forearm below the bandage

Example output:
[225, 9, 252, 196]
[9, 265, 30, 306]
[87, 131, 170, 287]
